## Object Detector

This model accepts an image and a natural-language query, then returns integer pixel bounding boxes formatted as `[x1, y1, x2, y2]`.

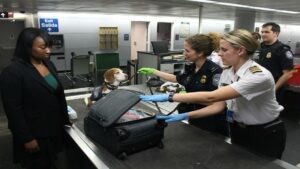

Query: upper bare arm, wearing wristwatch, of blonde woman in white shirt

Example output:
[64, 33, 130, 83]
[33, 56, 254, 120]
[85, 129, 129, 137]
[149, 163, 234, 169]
[173, 85, 240, 103]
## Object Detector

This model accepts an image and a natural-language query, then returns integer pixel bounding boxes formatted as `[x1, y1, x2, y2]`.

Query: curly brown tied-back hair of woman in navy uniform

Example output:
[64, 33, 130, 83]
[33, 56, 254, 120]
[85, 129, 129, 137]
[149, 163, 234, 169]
[185, 33, 220, 56]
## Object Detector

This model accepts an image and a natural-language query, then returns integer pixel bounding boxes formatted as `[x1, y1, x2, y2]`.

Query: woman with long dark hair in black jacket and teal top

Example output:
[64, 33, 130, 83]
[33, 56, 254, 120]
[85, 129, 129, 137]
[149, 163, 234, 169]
[0, 28, 71, 169]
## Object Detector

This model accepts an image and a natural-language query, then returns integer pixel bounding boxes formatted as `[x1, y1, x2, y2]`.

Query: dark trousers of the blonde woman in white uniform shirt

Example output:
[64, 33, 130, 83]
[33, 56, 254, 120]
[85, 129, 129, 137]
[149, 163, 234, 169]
[230, 119, 286, 159]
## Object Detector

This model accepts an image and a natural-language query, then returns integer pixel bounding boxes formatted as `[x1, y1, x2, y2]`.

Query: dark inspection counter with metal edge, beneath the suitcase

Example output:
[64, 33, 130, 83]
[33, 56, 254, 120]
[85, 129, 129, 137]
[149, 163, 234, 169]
[66, 85, 297, 169]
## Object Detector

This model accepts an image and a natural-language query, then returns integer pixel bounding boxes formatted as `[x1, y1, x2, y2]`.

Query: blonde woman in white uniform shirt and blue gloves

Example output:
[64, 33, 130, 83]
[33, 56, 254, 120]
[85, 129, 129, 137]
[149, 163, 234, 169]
[140, 29, 286, 158]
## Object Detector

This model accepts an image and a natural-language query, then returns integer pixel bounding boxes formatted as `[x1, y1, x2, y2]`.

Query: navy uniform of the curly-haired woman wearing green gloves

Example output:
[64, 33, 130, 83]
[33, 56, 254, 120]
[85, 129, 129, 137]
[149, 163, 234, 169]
[176, 59, 227, 135]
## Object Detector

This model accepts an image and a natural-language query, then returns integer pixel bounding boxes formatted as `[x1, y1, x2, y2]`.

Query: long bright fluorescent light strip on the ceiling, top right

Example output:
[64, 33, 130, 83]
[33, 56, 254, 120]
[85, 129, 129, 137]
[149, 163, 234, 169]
[188, 0, 300, 14]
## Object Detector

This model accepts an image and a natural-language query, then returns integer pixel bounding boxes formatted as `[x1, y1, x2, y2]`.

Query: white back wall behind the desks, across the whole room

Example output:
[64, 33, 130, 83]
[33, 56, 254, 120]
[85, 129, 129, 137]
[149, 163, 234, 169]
[33, 12, 300, 69]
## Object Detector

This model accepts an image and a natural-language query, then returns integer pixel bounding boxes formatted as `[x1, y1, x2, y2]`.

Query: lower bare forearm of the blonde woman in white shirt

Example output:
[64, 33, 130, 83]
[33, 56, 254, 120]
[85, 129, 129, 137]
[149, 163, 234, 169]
[188, 101, 225, 119]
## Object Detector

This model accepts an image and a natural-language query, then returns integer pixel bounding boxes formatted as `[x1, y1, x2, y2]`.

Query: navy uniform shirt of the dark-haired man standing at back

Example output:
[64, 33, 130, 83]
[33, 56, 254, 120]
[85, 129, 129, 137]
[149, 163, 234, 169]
[258, 41, 293, 82]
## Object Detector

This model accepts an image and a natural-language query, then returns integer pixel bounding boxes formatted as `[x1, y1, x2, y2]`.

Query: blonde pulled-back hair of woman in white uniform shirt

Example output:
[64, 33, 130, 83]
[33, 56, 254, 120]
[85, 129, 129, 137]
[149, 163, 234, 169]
[221, 29, 259, 55]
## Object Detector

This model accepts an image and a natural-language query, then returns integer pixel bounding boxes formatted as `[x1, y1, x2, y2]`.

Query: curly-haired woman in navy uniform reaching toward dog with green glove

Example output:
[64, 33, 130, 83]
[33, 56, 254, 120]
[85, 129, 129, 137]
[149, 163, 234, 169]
[138, 34, 227, 135]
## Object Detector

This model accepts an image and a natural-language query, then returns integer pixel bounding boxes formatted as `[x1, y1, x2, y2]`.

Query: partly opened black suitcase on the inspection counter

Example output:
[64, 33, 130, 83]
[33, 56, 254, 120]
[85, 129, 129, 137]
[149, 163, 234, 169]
[84, 89, 167, 159]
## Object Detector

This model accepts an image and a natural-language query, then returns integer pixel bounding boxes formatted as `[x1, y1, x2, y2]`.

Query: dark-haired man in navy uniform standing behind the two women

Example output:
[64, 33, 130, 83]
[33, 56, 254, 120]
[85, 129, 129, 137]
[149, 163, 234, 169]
[258, 22, 293, 103]
